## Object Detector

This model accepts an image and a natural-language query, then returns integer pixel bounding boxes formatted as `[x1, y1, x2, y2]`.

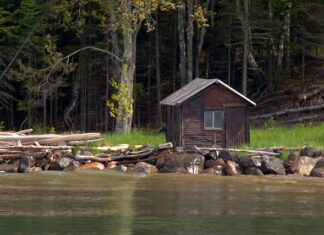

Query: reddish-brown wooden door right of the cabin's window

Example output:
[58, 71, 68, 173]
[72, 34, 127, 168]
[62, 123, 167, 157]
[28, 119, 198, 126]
[225, 107, 246, 147]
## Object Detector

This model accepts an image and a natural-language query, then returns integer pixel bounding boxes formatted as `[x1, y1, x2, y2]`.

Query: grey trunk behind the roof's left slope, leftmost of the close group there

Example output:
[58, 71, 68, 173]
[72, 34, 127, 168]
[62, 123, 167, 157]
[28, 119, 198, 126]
[178, 8, 187, 87]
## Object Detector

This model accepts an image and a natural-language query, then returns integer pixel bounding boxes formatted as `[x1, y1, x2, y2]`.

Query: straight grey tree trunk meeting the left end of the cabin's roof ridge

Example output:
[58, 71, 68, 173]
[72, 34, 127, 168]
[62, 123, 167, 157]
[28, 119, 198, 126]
[187, 0, 194, 82]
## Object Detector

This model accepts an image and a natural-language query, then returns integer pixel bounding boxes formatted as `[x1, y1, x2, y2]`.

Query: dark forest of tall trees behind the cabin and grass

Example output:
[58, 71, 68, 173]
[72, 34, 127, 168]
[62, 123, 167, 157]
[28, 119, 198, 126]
[0, 0, 324, 133]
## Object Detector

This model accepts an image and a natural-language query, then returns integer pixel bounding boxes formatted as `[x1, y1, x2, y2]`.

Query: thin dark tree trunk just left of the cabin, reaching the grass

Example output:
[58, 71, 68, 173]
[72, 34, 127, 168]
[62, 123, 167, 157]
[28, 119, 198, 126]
[155, 12, 162, 128]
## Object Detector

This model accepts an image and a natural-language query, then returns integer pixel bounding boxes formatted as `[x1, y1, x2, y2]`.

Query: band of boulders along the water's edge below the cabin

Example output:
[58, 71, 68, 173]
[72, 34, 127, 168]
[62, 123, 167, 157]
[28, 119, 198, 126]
[0, 144, 324, 177]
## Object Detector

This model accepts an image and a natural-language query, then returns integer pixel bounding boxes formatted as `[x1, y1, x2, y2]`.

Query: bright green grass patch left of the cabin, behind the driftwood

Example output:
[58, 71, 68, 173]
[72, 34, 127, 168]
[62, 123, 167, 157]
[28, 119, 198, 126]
[96, 129, 166, 147]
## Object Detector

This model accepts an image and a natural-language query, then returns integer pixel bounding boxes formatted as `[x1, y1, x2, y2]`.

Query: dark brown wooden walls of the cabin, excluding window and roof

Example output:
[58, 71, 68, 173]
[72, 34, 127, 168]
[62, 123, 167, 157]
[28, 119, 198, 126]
[167, 84, 250, 147]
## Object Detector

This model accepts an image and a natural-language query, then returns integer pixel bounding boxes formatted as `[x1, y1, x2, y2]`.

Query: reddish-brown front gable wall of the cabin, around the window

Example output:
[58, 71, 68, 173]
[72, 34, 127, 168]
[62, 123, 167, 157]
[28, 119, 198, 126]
[181, 84, 247, 147]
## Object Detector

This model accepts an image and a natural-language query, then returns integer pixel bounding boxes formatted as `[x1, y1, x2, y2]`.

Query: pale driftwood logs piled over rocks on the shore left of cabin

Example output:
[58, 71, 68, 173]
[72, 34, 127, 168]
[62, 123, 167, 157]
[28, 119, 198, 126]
[0, 129, 173, 172]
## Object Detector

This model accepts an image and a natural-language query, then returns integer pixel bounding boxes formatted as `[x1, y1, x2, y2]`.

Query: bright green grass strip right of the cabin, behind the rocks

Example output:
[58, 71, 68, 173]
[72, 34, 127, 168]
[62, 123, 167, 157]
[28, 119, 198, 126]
[248, 123, 324, 149]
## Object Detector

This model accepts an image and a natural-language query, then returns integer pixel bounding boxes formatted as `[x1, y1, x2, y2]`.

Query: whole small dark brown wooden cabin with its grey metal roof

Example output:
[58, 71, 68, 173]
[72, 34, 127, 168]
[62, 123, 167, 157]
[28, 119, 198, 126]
[161, 78, 256, 147]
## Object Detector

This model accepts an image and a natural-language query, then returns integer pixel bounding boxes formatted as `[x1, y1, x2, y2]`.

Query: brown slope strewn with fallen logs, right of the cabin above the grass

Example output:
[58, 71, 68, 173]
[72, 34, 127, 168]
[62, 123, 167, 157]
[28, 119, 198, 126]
[251, 81, 324, 125]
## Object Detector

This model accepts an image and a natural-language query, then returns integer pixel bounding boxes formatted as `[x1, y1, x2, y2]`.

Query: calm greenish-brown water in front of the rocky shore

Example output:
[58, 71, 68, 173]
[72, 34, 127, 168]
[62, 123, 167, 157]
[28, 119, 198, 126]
[0, 171, 324, 235]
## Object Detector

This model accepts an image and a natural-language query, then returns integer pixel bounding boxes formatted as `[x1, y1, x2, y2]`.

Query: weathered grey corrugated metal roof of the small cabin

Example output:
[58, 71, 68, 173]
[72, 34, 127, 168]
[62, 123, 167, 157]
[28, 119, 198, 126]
[161, 78, 256, 106]
